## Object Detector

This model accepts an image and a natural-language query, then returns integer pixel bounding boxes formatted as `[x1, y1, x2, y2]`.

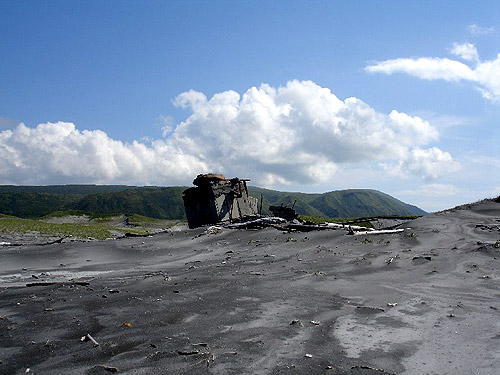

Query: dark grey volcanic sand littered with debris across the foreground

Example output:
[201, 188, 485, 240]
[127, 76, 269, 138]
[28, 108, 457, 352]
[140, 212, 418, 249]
[0, 201, 500, 375]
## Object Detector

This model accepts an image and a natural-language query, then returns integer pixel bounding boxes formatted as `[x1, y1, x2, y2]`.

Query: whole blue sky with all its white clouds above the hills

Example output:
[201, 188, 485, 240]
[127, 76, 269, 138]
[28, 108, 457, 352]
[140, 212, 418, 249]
[0, 0, 500, 211]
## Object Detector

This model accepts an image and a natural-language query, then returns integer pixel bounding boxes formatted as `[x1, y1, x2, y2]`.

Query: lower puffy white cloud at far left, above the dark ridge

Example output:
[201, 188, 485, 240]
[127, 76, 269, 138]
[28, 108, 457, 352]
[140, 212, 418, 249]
[0, 122, 206, 184]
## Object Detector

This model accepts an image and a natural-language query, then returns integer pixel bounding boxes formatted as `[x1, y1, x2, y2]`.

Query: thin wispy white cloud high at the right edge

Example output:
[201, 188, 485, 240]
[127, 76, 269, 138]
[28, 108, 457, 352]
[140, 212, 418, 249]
[365, 43, 500, 103]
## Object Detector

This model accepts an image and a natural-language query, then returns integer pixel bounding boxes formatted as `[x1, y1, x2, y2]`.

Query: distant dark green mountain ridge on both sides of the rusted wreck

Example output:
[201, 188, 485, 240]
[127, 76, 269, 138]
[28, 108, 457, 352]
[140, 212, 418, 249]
[0, 185, 426, 219]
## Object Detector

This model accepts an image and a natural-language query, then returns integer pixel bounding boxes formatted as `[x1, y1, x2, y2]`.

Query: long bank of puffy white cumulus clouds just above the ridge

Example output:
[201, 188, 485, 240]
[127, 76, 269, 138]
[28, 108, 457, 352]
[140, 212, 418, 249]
[0, 80, 456, 186]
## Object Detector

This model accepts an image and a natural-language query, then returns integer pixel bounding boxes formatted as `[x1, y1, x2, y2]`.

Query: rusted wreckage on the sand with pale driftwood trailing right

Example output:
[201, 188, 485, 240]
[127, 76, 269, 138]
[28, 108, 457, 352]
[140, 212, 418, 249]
[182, 173, 403, 235]
